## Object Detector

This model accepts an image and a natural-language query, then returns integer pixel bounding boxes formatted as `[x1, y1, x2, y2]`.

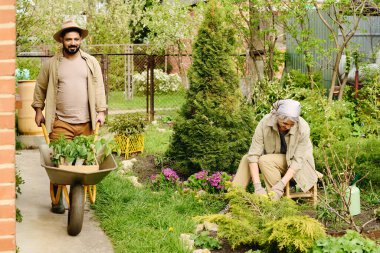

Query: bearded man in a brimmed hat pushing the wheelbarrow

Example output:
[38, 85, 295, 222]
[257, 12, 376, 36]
[32, 20, 107, 213]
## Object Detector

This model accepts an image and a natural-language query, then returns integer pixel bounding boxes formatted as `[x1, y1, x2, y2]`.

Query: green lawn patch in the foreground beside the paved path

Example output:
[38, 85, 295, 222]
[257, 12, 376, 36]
[93, 173, 223, 253]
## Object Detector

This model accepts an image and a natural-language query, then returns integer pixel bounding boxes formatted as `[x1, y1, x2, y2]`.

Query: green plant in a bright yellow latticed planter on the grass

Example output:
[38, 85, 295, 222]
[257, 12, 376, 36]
[109, 113, 146, 159]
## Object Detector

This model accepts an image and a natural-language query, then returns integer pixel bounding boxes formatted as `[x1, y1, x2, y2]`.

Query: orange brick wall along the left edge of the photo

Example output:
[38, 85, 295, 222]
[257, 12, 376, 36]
[0, 0, 16, 253]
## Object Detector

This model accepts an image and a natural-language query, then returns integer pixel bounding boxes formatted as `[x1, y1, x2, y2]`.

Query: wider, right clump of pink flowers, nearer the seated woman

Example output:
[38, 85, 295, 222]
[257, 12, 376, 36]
[184, 170, 232, 193]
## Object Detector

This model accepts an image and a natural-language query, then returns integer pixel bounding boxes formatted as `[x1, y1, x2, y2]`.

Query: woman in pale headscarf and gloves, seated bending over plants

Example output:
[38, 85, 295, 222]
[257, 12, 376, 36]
[233, 99, 318, 200]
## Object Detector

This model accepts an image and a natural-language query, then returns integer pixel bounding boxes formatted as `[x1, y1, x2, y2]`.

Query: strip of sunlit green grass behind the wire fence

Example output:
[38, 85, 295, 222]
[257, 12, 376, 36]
[108, 91, 185, 110]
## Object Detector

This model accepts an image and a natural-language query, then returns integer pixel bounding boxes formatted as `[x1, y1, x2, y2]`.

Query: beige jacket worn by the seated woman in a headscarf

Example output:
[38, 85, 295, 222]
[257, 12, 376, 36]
[247, 114, 318, 192]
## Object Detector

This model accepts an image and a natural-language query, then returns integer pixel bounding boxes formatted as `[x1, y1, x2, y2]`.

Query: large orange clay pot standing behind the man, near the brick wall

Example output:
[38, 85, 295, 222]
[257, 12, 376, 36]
[17, 80, 43, 135]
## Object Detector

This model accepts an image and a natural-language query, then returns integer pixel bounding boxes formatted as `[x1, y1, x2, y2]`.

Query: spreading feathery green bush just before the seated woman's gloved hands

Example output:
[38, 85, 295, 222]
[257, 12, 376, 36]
[195, 188, 299, 248]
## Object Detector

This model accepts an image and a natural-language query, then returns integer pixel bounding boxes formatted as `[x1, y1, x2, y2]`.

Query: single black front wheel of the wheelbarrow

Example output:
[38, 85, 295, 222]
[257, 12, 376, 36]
[67, 184, 85, 236]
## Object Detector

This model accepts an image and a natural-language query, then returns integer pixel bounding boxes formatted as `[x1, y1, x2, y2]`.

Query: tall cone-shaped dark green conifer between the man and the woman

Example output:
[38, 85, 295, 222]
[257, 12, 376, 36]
[167, 0, 254, 175]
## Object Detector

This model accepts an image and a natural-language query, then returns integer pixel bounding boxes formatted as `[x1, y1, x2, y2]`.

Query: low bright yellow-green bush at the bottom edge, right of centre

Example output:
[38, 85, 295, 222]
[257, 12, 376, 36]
[262, 216, 326, 252]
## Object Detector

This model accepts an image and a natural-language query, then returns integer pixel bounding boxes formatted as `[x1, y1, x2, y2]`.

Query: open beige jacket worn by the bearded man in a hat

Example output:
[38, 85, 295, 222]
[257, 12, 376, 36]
[32, 50, 107, 133]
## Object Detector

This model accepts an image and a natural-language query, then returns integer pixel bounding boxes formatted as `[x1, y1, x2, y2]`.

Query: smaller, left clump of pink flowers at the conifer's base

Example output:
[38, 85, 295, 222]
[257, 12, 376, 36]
[150, 168, 180, 191]
